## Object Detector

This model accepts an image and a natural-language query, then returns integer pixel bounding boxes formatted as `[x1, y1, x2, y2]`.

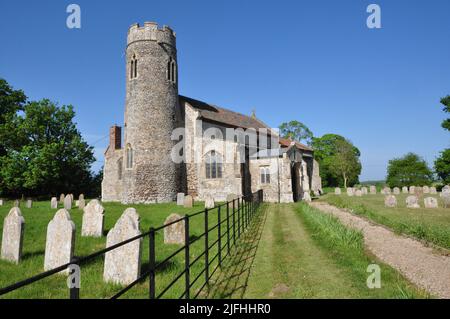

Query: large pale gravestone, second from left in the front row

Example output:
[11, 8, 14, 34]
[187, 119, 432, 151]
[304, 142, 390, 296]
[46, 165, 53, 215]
[44, 209, 75, 272]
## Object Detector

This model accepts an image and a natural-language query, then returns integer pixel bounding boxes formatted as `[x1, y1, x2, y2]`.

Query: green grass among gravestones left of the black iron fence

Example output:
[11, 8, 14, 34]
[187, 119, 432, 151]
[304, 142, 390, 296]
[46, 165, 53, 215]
[0, 200, 226, 298]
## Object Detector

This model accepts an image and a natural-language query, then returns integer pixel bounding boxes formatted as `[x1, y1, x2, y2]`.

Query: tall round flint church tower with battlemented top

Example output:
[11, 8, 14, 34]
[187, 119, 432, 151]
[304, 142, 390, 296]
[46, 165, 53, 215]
[122, 22, 178, 203]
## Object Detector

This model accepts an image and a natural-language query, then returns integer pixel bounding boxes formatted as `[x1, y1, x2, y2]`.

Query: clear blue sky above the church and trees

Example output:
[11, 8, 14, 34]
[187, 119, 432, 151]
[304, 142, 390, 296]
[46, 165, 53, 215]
[0, 0, 450, 180]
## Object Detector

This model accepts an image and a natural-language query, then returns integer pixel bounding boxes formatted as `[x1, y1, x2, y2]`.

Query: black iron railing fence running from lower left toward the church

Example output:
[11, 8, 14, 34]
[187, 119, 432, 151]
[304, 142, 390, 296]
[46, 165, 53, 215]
[0, 190, 263, 299]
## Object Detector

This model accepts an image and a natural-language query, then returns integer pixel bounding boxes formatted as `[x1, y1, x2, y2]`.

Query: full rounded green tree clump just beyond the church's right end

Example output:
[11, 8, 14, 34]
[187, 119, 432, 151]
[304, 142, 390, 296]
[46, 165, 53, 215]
[311, 134, 361, 187]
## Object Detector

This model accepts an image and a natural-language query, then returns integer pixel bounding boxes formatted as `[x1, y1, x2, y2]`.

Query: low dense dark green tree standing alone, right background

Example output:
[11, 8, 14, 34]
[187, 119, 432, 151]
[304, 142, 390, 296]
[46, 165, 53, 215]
[386, 153, 433, 187]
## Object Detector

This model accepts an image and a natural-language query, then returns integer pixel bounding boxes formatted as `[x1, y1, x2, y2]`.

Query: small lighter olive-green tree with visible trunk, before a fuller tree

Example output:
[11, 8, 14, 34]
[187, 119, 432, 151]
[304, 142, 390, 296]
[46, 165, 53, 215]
[329, 139, 361, 188]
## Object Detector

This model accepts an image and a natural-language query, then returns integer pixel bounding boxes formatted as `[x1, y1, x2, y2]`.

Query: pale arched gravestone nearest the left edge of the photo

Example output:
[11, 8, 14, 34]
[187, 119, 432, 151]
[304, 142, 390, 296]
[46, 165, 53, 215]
[1, 207, 25, 264]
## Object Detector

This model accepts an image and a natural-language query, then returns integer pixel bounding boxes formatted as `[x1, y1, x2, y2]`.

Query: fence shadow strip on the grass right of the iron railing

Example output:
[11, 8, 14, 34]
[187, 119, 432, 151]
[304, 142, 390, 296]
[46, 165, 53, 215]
[202, 207, 267, 299]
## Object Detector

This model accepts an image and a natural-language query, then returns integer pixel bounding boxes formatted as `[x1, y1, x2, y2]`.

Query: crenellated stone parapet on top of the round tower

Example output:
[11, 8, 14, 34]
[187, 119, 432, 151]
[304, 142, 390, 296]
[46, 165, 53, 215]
[127, 22, 176, 47]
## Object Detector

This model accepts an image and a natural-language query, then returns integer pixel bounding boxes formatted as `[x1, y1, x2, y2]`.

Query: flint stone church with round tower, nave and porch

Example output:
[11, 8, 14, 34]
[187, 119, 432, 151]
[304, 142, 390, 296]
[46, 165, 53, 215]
[102, 22, 322, 204]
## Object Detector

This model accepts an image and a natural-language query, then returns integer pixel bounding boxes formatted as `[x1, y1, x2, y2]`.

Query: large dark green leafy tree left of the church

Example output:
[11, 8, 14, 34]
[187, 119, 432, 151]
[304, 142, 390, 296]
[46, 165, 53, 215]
[0, 82, 94, 196]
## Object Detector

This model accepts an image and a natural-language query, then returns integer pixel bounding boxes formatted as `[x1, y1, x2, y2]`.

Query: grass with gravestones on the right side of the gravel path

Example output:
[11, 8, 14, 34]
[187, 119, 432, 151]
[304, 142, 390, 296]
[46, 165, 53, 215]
[320, 193, 450, 249]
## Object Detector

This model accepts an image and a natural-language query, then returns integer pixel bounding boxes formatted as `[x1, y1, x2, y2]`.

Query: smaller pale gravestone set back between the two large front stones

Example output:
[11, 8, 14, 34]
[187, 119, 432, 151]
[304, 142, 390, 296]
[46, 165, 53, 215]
[81, 199, 105, 237]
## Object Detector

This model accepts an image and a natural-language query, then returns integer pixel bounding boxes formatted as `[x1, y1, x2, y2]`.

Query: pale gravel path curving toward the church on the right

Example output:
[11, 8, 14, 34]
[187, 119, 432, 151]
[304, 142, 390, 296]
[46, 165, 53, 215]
[311, 202, 450, 299]
